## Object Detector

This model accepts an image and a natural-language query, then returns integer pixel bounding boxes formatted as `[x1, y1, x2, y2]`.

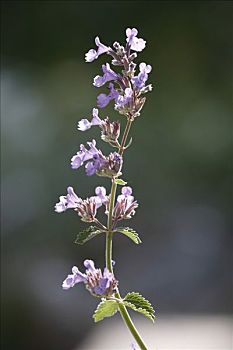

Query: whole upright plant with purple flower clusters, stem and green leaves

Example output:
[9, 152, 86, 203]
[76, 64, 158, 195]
[55, 28, 155, 350]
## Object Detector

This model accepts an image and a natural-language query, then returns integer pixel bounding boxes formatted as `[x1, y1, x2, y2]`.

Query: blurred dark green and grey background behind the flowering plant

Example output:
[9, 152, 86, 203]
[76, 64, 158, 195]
[1, 1, 232, 350]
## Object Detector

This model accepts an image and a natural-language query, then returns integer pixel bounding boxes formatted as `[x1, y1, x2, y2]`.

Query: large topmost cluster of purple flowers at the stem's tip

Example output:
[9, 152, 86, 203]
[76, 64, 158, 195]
[81, 28, 152, 119]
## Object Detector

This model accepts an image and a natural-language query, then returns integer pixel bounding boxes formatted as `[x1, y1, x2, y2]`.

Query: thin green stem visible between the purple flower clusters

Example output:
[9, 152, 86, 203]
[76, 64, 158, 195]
[105, 118, 147, 350]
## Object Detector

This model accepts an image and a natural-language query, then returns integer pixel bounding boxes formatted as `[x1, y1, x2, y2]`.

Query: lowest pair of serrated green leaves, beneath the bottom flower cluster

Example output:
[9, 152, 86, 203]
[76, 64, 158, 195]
[93, 292, 155, 322]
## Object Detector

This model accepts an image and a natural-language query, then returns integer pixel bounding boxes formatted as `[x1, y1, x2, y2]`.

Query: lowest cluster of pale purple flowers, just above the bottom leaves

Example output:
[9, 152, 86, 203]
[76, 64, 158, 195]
[62, 260, 118, 297]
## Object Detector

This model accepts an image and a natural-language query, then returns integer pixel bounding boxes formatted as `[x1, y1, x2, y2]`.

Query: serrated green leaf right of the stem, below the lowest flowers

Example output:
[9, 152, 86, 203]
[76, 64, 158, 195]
[123, 292, 155, 322]
